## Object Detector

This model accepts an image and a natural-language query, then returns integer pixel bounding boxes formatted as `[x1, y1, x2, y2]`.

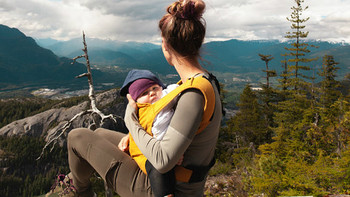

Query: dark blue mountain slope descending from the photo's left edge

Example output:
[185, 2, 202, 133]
[0, 25, 86, 85]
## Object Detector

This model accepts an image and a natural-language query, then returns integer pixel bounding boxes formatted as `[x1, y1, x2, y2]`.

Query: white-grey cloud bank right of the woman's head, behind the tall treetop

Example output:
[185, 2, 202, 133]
[207, 0, 350, 43]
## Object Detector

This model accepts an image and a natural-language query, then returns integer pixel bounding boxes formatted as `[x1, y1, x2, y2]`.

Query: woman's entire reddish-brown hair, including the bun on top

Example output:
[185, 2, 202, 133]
[159, 0, 206, 57]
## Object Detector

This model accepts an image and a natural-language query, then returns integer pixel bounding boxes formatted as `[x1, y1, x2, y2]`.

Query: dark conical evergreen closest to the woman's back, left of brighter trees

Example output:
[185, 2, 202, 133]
[216, 84, 271, 167]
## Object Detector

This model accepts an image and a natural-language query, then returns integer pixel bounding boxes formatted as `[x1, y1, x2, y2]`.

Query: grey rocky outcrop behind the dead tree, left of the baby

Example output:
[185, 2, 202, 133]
[0, 89, 127, 139]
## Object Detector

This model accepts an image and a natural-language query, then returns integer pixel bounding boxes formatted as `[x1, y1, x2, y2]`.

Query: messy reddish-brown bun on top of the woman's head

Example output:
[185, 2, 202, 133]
[168, 0, 205, 20]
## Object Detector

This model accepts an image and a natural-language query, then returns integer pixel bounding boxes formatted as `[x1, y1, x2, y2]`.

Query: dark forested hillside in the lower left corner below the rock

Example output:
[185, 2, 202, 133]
[0, 136, 68, 197]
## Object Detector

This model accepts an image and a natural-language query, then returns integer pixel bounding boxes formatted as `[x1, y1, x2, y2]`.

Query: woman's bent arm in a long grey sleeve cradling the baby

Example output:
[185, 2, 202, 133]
[124, 89, 204, 173]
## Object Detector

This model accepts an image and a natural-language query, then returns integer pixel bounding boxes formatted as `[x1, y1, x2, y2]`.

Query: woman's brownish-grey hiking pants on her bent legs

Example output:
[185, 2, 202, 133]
[68, 128, 152, 197]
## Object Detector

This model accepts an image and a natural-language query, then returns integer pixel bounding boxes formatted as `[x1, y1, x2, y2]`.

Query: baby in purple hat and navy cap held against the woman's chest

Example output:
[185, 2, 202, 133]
[120, 69, 181, 197]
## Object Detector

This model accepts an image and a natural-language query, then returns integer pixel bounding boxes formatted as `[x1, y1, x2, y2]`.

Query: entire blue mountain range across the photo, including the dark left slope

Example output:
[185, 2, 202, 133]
[0, 25, 350, 91]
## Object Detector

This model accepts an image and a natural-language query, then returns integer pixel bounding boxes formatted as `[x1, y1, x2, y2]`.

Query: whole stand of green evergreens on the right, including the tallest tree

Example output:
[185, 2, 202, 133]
[209, 0, 350, 197]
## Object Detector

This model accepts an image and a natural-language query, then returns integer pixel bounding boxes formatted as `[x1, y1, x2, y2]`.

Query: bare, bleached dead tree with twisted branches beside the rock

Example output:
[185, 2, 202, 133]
[37, 32, 118, 160]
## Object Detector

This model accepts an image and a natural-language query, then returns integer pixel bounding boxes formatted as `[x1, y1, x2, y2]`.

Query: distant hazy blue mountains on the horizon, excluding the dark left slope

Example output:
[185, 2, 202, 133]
[37, 33, 350, 74]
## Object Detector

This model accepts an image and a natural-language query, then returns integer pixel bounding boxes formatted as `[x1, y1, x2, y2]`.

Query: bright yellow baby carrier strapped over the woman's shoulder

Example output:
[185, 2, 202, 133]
[129, 74, 215, 182]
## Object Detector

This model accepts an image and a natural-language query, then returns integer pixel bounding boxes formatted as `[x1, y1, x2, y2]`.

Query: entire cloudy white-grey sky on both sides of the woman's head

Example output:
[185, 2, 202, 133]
[0, 0, 350, 43]
